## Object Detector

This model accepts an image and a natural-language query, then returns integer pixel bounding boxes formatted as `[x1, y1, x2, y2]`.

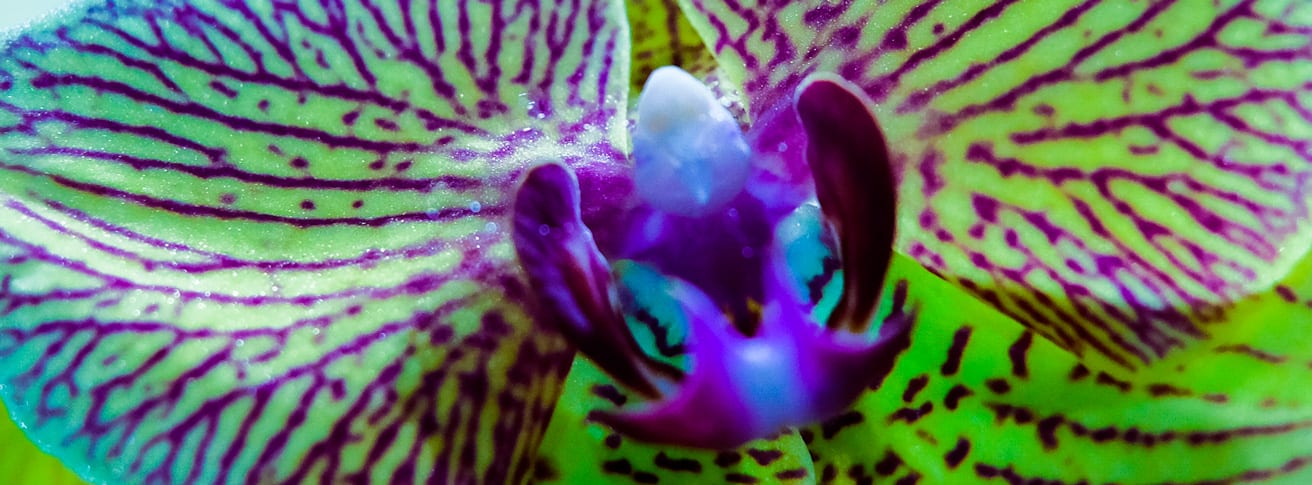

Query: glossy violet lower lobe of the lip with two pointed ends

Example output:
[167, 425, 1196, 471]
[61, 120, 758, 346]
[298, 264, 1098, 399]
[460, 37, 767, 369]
[590, 276, 916, 450]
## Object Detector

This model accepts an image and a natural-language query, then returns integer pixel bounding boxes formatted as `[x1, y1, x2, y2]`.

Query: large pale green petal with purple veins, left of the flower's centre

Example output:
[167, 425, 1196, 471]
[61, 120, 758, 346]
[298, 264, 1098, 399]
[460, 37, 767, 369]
[0, 0, 627, 484]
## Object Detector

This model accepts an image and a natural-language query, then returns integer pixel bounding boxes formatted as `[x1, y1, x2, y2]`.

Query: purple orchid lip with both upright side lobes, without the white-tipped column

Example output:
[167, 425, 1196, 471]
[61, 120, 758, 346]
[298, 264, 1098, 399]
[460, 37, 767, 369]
[514, 67, 914, 448]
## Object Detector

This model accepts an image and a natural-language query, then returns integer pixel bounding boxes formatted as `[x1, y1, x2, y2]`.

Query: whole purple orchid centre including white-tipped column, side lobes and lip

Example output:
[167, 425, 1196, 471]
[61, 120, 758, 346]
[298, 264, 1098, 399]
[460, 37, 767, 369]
[514, 68, 914, 448]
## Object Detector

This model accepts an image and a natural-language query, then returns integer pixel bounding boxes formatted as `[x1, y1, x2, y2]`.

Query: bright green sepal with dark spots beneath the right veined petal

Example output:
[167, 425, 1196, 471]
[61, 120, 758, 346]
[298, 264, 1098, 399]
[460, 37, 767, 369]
[802, 257, 1312, 484]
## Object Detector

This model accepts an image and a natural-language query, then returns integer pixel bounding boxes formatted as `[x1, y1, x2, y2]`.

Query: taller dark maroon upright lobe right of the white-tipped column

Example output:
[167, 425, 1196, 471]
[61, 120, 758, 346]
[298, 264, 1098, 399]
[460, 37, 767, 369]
[795, 77, 897, 332]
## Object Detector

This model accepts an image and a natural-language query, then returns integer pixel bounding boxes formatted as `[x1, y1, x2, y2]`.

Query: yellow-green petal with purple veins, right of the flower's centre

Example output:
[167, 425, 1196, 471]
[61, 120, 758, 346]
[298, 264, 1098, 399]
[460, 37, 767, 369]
[693, 0, 1312, 374]
